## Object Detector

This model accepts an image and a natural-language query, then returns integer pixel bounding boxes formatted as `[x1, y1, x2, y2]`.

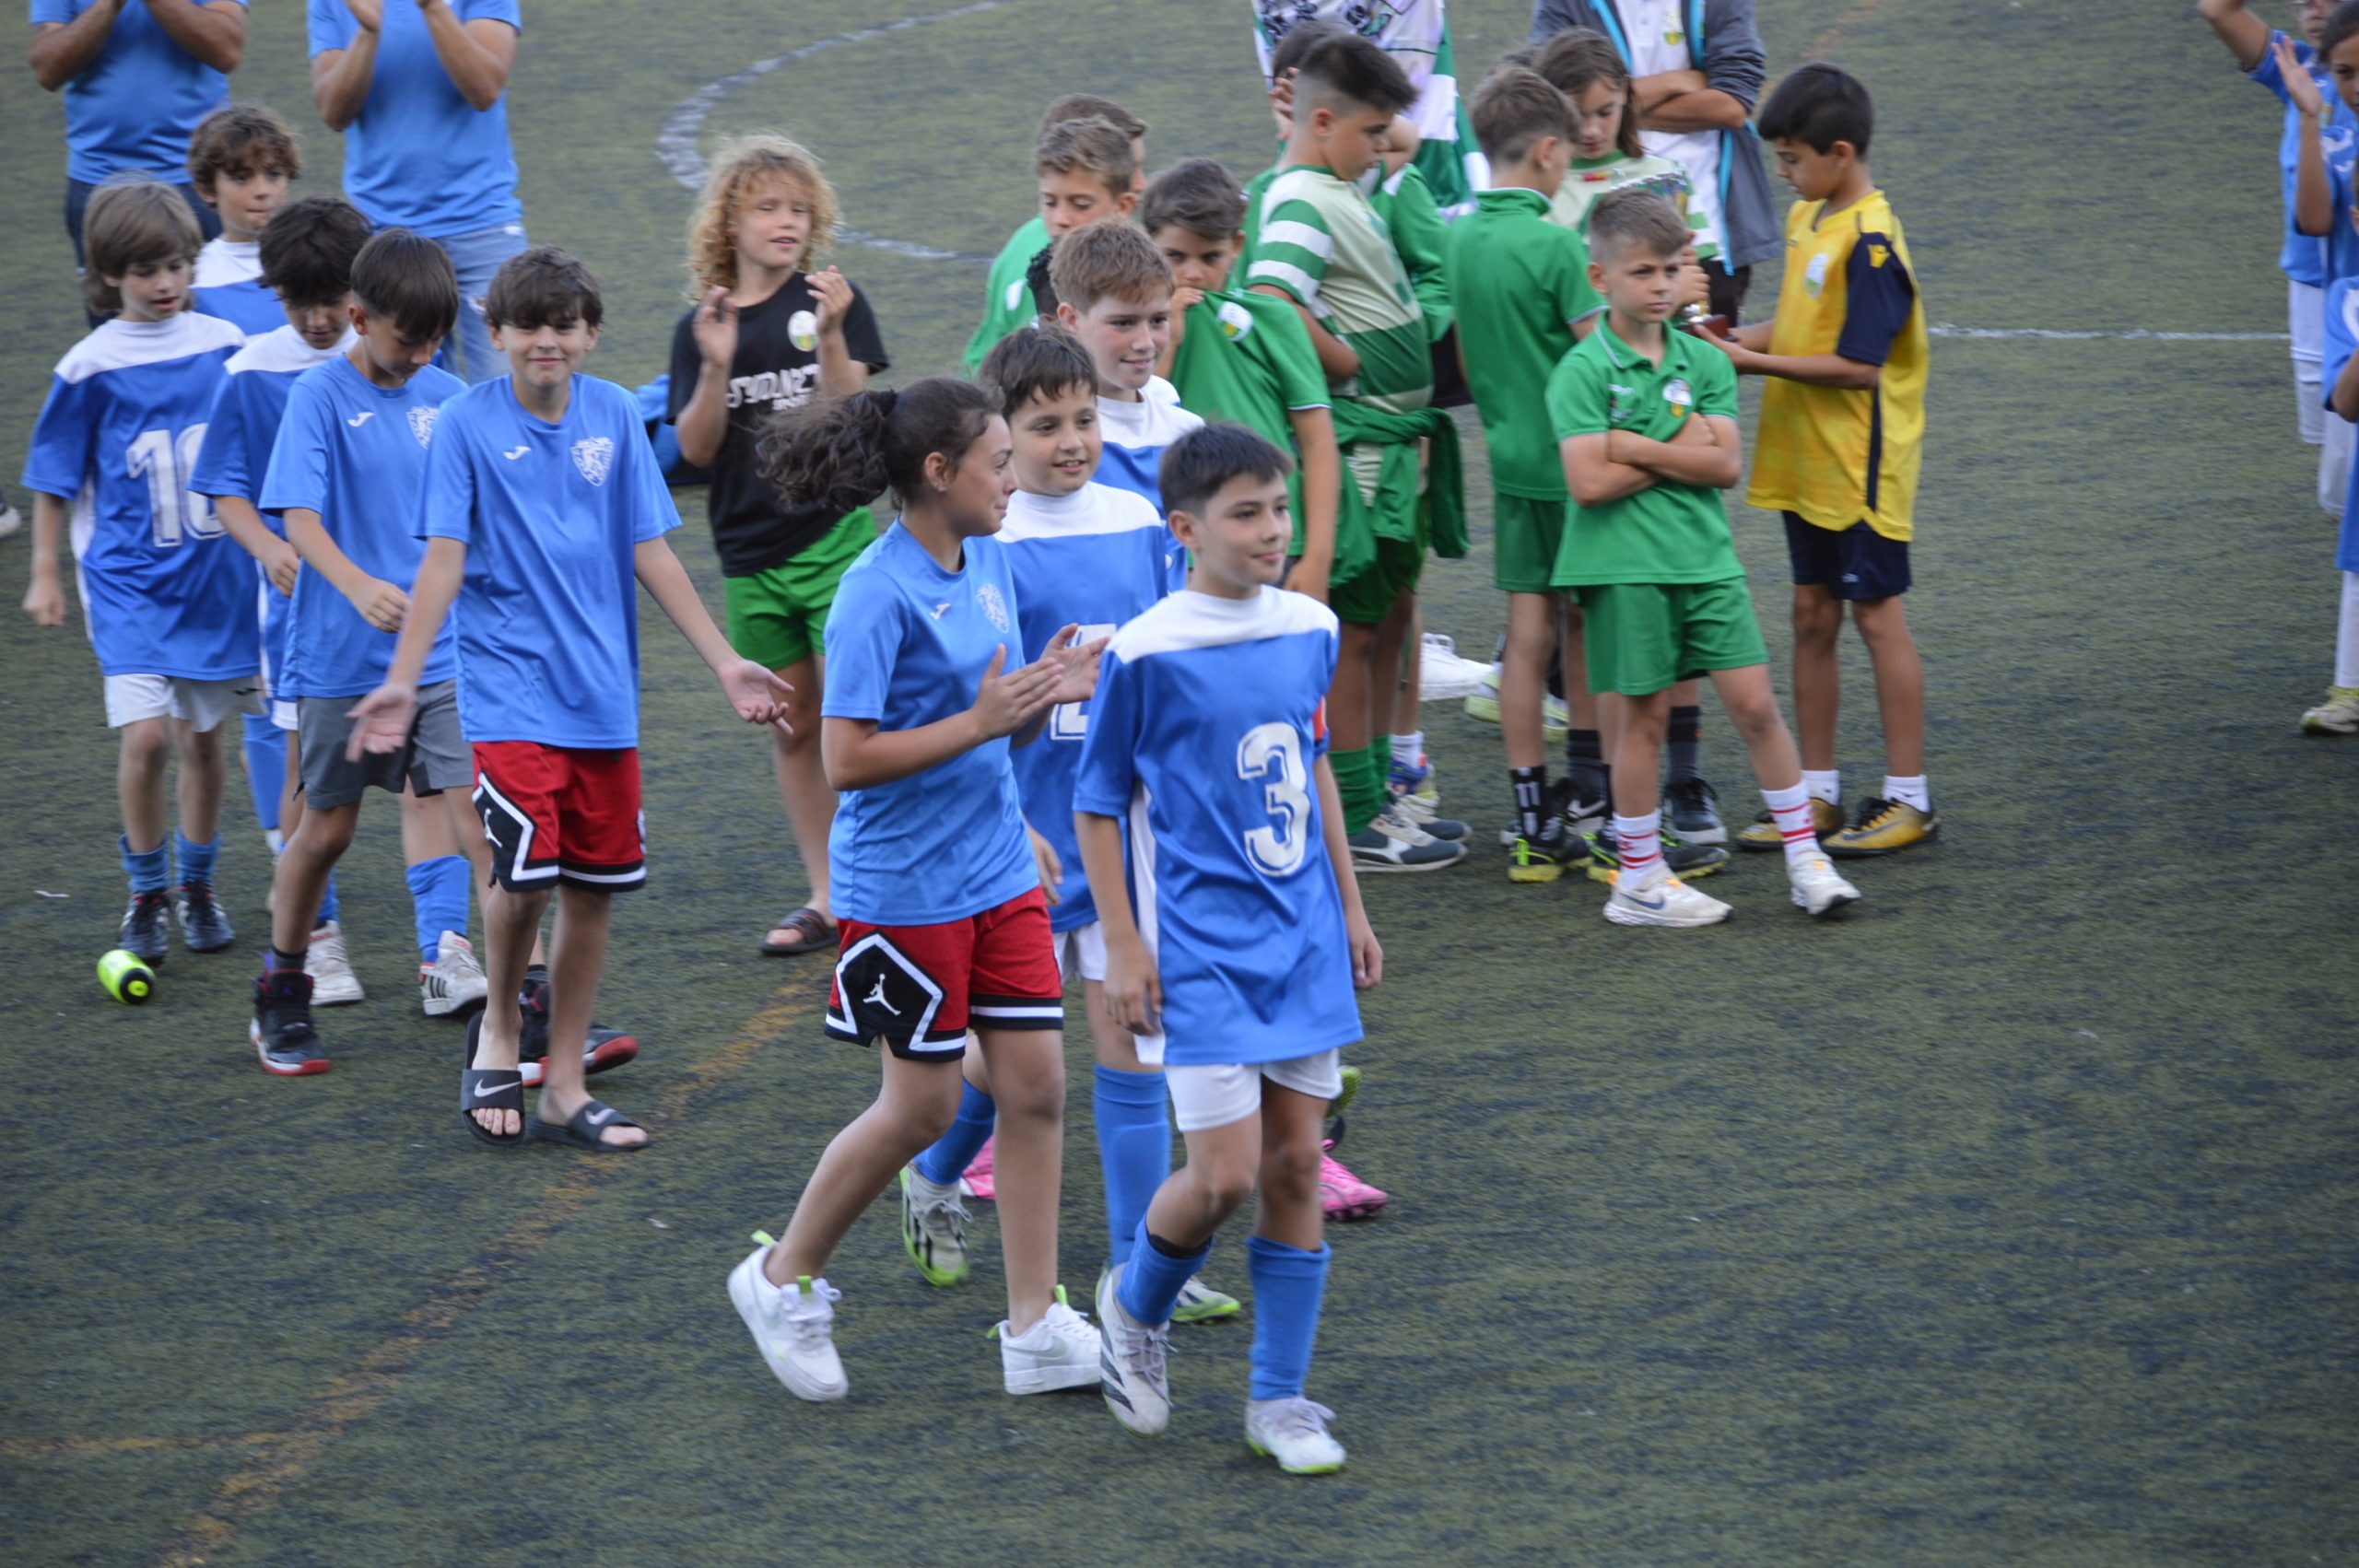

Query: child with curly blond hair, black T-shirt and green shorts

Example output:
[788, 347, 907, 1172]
[670, 136, 885, 957]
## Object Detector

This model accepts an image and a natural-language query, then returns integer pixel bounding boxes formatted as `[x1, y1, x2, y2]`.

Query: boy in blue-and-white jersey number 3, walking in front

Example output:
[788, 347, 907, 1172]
[1074, 425, 1385, 1474]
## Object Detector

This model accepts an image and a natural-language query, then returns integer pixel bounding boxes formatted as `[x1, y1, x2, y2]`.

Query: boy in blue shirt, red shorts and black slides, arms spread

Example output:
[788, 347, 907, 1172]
[345, 248, 785, 1151]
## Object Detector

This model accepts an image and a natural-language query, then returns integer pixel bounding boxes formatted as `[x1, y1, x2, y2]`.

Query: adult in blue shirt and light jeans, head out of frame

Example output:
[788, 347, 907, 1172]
[309, 0, 526, 382]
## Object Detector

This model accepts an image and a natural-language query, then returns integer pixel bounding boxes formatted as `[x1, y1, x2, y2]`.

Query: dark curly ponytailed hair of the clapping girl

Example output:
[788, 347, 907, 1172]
[755, 375, 1000, 517]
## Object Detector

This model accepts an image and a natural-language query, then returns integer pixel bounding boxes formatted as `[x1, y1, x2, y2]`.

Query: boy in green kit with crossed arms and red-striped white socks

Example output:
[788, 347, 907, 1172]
[1547, 191, 1859, 927]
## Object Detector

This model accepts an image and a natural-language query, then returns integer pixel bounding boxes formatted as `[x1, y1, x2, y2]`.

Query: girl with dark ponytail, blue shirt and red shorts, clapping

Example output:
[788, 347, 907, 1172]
[729, 378, 1104, 1400]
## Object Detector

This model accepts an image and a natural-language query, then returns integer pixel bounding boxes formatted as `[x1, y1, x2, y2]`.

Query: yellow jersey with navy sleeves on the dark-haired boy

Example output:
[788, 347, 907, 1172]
[1745, 191, 1928, 540]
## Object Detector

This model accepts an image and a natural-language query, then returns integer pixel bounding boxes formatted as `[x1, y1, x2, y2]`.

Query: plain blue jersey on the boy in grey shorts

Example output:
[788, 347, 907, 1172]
[262, 354, 467, 700]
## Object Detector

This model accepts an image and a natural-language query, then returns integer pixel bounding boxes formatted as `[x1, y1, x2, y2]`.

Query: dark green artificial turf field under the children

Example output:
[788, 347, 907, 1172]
[0, 0, 2359, 1563]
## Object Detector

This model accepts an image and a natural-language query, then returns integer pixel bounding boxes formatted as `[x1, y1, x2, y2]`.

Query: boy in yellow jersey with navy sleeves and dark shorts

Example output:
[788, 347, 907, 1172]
[1722, 66, 1942, 856]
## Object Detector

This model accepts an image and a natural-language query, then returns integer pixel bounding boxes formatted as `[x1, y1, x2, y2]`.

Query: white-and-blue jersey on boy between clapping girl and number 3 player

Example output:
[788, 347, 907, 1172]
[991, 484, 1187, 931]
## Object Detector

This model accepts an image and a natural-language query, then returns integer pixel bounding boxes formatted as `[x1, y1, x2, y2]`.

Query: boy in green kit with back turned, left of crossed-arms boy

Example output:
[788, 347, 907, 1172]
[1444, 66, 1600, 882]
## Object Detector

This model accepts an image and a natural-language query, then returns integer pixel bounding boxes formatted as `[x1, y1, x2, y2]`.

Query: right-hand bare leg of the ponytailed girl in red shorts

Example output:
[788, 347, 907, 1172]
[981, 1028, 1064, 1335]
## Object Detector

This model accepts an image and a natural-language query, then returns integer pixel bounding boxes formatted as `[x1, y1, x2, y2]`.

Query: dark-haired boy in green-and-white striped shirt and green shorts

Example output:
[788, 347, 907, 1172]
[1246, 33, 1465, 872]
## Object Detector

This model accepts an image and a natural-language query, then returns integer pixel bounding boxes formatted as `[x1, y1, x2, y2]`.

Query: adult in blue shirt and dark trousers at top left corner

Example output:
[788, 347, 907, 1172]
[26, 0, 245, 272]
